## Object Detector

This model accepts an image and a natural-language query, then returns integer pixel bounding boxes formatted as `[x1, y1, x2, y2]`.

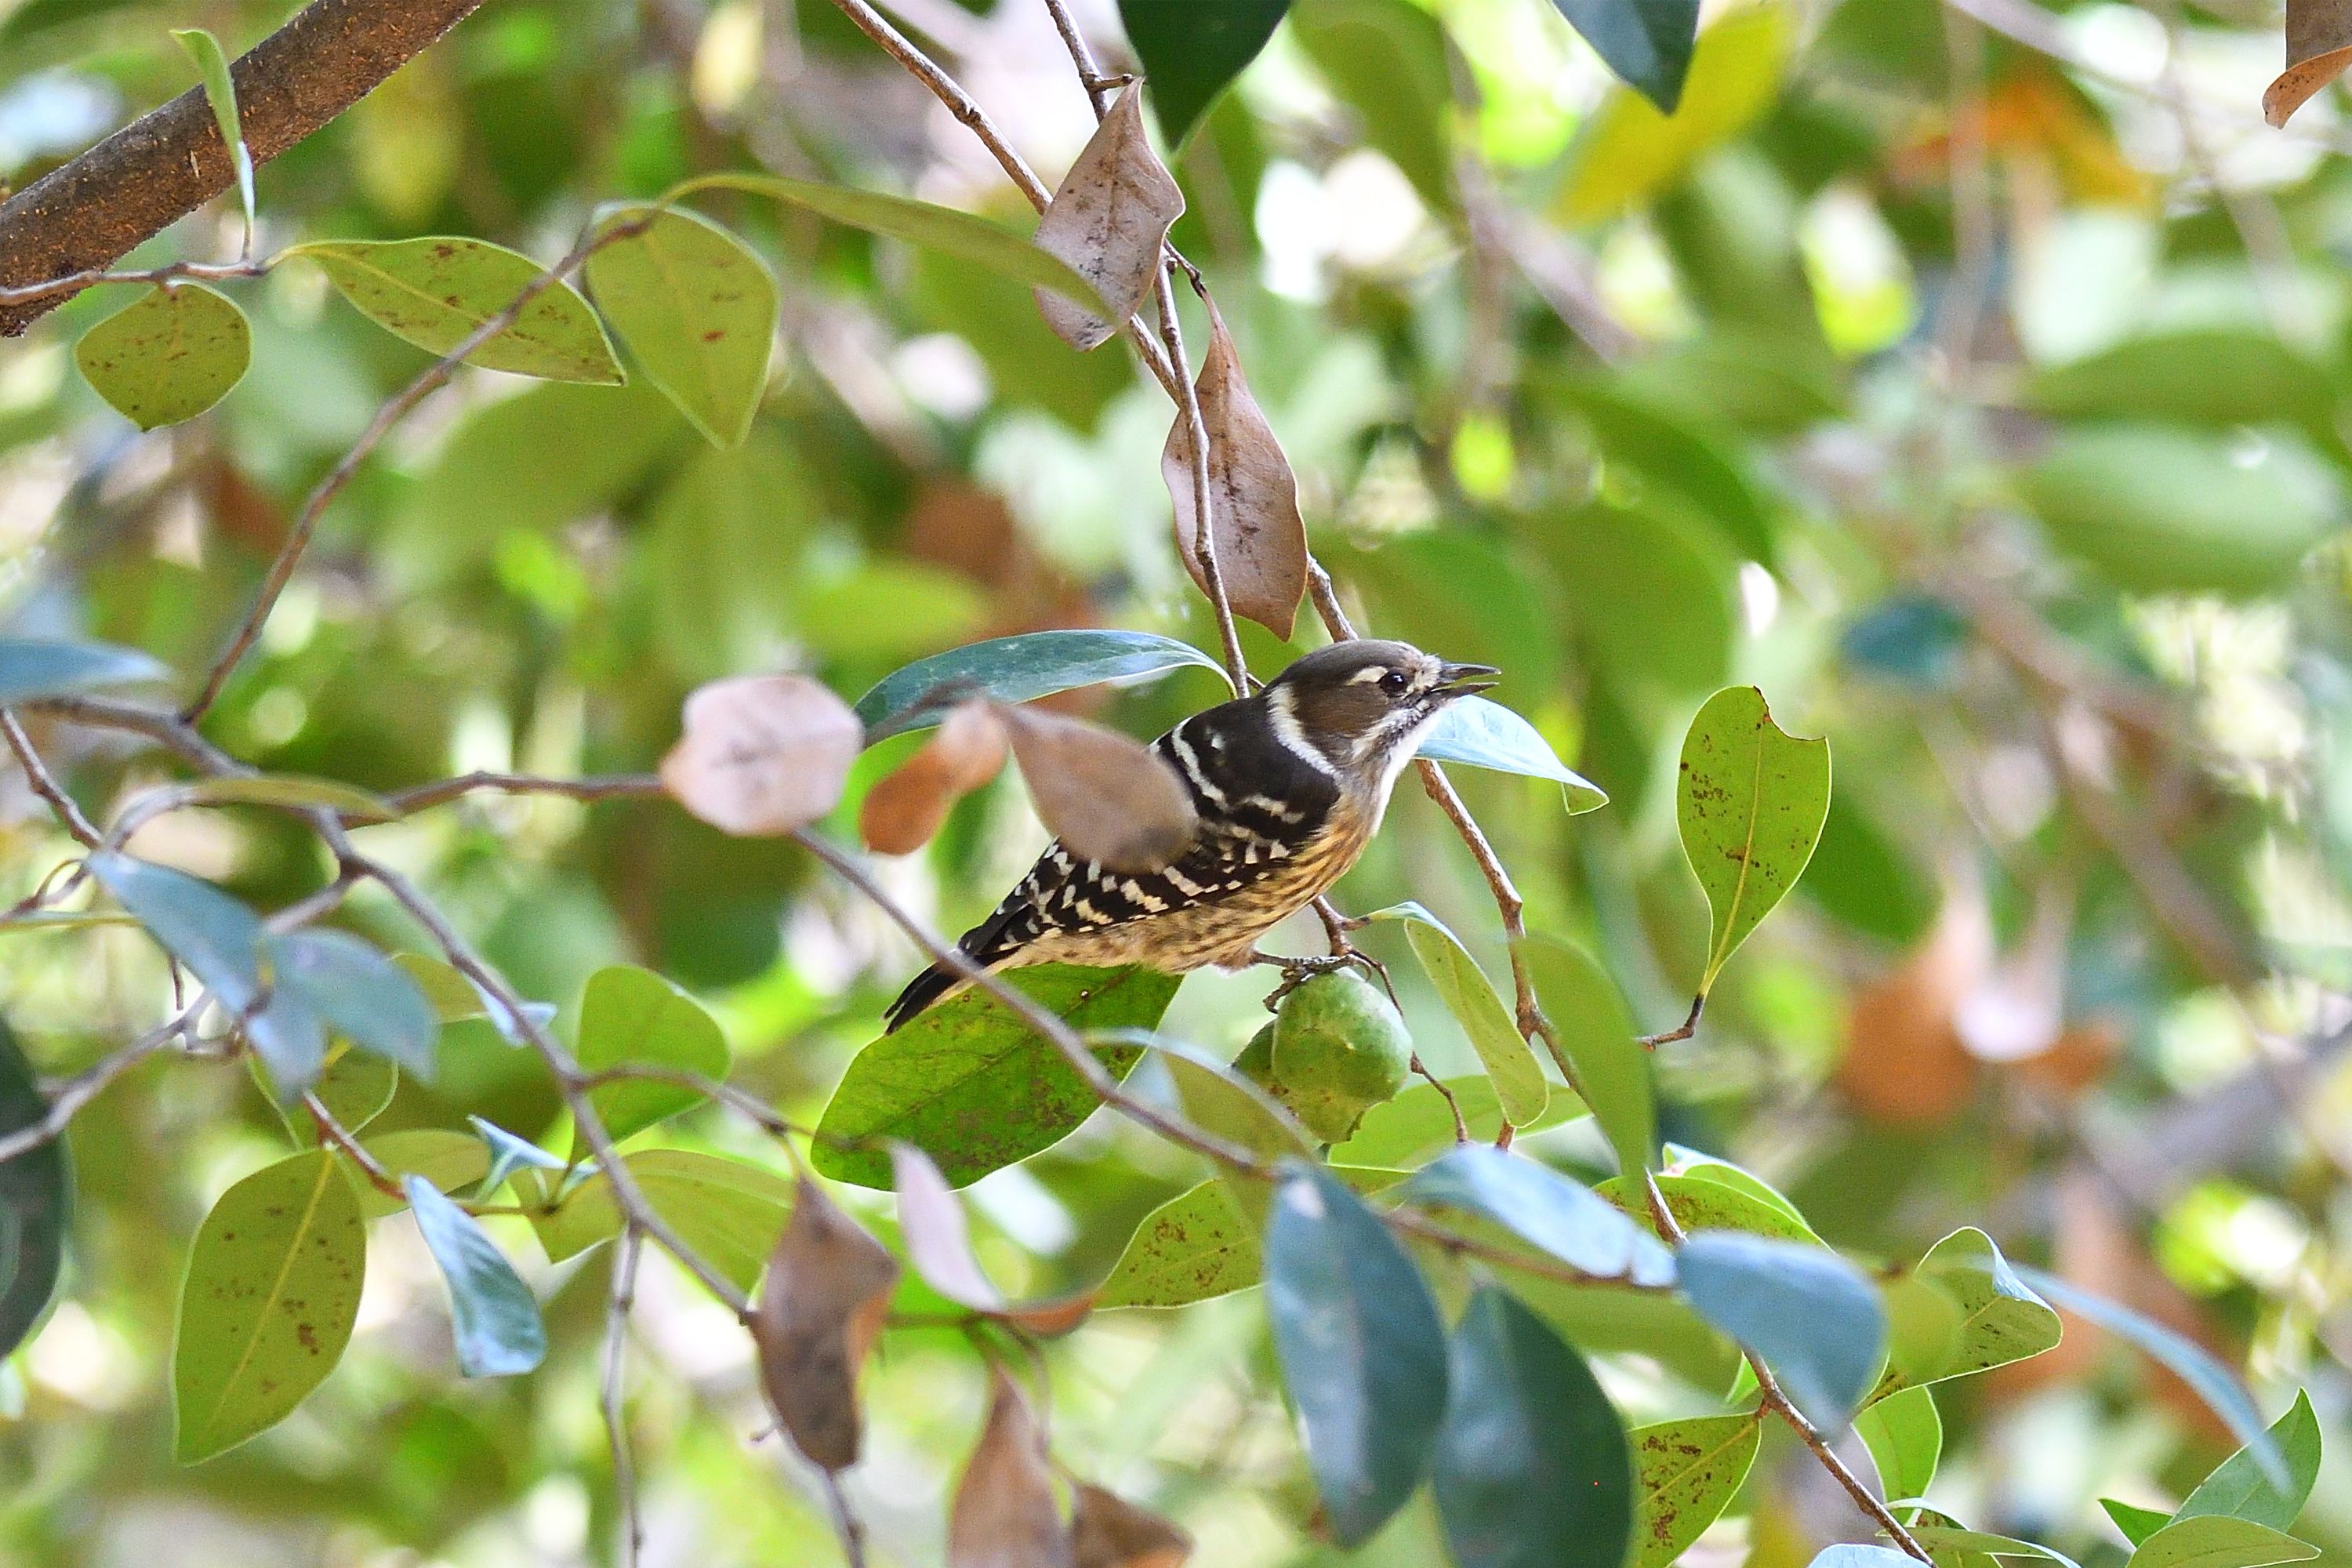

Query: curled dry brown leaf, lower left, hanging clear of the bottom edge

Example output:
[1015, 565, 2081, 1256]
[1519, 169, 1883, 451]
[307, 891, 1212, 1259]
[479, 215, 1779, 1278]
[750, 1175, 898, 1469]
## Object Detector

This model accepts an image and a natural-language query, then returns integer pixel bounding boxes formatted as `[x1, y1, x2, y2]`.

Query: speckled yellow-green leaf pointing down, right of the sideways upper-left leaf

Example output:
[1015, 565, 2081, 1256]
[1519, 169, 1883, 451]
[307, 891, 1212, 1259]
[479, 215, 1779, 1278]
[588, 207, 781, 447]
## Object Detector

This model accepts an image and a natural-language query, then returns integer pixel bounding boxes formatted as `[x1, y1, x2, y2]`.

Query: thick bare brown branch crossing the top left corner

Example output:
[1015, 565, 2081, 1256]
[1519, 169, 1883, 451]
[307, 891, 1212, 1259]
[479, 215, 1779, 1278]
[0, 0, 482, 336]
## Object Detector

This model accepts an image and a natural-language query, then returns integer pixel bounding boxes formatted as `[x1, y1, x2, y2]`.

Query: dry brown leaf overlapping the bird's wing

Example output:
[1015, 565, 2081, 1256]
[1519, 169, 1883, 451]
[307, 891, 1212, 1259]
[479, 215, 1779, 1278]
[997, 708, 1200, 874]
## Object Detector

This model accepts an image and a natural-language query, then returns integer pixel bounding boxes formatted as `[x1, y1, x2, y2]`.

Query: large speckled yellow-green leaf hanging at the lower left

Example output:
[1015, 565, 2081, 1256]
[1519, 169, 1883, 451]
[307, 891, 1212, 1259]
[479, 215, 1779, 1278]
[172, 1149, 367, 1465]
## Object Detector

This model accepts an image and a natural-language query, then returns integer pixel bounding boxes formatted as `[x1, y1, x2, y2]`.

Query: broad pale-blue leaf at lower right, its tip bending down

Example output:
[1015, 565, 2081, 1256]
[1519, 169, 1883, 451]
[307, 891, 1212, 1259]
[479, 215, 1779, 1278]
[1675, 1229, 1886, 1432]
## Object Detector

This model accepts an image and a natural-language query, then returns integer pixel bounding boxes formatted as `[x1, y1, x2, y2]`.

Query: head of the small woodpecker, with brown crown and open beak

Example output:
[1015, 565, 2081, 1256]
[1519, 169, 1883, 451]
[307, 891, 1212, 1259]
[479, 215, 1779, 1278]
[1265, 637, 1498, 783]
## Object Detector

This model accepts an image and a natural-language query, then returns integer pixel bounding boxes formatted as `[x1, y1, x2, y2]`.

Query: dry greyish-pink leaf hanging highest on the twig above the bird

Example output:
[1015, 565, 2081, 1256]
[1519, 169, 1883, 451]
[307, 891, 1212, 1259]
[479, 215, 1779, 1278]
[1035, 82, 1183, 348]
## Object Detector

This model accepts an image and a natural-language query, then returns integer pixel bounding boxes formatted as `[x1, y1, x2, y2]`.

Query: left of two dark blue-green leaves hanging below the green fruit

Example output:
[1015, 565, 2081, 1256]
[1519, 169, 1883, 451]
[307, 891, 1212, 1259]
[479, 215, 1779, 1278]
[1265, 1161, 1446, 1547]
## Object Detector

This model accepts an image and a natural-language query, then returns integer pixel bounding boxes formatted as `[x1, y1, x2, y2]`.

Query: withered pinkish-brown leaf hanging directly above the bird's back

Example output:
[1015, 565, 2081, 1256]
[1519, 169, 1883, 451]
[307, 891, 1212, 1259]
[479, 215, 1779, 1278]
[1160, 301, 1308, 640]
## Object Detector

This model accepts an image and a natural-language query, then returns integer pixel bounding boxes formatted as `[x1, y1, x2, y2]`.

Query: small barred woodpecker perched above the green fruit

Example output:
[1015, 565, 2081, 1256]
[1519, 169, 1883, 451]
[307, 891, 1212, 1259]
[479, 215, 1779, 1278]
[884, 640, 1494, 1029]
